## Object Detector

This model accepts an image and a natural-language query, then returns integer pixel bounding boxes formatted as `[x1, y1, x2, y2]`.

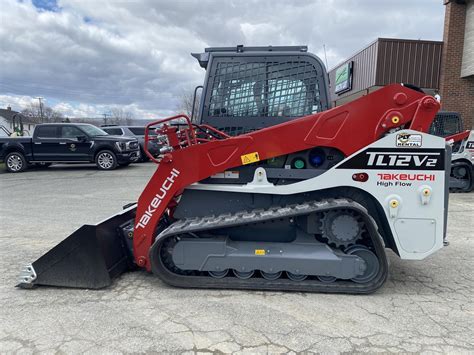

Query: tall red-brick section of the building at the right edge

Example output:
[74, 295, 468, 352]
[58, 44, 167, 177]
[440, 0, 474, 129]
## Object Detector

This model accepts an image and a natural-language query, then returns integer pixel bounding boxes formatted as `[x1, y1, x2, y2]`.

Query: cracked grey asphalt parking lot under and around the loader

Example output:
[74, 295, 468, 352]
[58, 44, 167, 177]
[0, 163, 474, 353]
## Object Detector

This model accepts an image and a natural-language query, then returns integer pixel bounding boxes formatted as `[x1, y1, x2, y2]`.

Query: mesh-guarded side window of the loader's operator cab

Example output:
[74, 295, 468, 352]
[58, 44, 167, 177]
[207, 58, 322, 119]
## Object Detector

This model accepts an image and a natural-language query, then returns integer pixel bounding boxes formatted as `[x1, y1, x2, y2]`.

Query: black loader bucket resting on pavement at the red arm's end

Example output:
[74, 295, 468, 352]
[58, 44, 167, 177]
[17, 204, 136, 289]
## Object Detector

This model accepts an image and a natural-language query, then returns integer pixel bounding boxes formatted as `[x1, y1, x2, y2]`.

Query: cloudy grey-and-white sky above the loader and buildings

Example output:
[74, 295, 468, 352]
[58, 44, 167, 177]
[0, 0, 444, 116]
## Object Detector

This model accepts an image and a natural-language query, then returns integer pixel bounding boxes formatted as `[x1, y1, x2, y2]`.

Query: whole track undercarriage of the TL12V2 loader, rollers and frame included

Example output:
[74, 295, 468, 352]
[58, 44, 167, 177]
[150, 198, 388, 293]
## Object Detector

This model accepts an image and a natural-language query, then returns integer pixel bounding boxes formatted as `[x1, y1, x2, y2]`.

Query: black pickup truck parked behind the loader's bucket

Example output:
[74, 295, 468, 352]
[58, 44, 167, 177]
[0, 123, 140, 173]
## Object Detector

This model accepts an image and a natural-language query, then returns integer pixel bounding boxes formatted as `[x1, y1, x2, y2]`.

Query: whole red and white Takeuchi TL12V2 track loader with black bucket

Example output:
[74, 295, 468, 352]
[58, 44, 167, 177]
[19, 46, 462, 293]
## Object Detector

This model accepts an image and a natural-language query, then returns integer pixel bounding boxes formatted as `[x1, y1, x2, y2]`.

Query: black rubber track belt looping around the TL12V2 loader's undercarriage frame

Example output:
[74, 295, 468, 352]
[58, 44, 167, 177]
[150, 198, 388, 294]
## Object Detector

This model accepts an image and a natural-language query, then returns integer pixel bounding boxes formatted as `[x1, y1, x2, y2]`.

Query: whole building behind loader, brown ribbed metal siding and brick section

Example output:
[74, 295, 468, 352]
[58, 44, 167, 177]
[329, 0, 474, 129]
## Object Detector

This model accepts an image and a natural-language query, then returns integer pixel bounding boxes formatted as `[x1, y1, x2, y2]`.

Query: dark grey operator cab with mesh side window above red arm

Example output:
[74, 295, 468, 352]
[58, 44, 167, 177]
[192, 46, 329, 135]
